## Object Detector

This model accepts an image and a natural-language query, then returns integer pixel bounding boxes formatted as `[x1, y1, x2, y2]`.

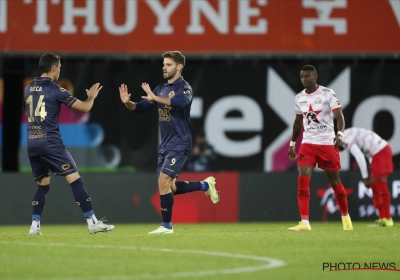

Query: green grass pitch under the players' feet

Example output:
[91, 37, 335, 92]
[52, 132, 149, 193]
[0, 222, 400, 280]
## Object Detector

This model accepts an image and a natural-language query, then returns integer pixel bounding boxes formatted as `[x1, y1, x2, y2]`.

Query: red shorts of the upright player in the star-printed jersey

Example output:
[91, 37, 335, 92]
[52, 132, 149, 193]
[297, 144, 340, 171]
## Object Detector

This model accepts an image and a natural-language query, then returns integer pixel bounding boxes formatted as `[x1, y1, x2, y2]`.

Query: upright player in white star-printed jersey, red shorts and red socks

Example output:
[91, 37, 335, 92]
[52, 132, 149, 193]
[288, 65, 353, 231]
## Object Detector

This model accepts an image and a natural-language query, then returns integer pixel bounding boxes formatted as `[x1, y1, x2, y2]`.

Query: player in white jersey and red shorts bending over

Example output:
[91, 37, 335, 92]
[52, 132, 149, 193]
[339, 127, 393, 227]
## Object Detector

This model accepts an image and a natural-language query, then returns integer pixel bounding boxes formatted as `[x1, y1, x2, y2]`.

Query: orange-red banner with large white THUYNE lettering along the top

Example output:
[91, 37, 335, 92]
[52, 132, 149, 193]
[0, 0, 400, 54]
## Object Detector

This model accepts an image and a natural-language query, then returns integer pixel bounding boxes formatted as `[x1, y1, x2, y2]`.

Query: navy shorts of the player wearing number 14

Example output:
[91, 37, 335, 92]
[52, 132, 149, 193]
[29, 149, 78, 181]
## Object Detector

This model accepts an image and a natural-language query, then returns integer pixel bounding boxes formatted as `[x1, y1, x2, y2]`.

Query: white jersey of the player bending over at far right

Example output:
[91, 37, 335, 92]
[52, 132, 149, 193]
[342, 127, 388, 158]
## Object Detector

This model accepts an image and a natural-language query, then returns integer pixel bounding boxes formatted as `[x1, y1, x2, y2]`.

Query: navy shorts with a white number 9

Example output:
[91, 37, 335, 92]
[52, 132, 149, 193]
[157, 150, 188, 178]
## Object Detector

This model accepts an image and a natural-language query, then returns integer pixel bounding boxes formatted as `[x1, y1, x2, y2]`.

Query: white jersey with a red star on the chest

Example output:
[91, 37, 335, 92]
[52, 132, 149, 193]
[294, 85, 342, 145]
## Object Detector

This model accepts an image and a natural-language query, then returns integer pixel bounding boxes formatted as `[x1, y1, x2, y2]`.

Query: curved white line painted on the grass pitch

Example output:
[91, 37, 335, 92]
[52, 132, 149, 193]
[0, 241, 286, 280]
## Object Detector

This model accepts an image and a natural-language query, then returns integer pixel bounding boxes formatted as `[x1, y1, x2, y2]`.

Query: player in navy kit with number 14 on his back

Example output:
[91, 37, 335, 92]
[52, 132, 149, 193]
[24, 53, 114, 235]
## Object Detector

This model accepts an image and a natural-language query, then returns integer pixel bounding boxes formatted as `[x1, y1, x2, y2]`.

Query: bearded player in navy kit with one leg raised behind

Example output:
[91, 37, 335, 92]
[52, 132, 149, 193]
[119, 51, 219, 234]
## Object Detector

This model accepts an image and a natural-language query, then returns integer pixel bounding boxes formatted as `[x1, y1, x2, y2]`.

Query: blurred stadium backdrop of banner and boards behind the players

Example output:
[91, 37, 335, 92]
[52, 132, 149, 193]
[0, 0, 400, 224]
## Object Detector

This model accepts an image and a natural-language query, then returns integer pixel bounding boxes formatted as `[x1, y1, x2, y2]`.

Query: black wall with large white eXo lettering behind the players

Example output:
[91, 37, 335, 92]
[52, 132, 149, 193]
[0, 55, 400, 172]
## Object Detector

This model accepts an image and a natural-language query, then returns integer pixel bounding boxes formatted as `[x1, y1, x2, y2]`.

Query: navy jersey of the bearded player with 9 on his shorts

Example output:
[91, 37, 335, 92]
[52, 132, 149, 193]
[134, 77, 193, 155]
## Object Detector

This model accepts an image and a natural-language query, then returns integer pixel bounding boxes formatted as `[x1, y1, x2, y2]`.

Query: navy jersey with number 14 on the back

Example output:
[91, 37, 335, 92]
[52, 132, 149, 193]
[24, 77, 77, 156]
